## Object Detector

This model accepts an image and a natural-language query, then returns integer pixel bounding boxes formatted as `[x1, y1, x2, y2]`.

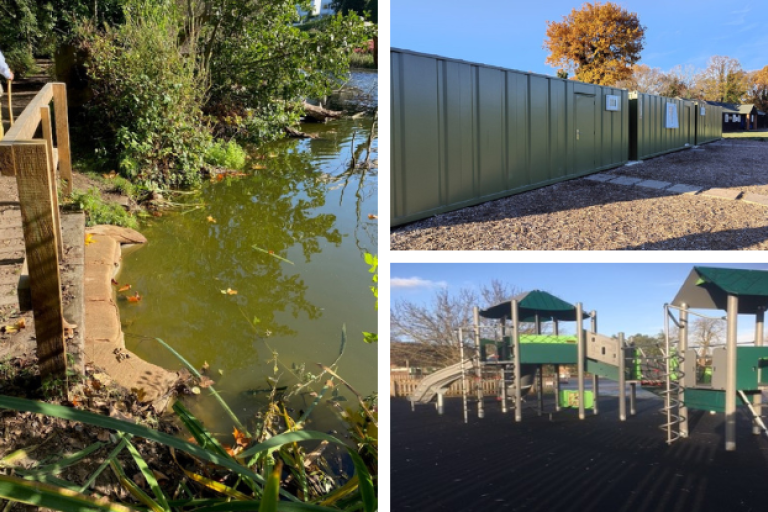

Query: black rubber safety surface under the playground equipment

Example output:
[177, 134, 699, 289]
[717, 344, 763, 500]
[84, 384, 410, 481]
[390, 396, 768, 512]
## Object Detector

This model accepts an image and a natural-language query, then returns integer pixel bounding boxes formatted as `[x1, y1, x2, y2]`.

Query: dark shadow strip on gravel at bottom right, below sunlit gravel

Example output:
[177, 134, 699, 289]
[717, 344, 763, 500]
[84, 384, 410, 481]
[622, 227, 768, 251]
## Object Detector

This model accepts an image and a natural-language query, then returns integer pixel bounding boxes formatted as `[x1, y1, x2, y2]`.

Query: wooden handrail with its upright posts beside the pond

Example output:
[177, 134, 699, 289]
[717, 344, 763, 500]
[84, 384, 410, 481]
[0, 83, 72, 376]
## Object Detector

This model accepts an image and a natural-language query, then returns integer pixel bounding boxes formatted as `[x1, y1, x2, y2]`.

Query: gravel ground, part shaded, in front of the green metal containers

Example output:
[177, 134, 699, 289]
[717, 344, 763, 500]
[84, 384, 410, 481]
[390, 141, 768, 250]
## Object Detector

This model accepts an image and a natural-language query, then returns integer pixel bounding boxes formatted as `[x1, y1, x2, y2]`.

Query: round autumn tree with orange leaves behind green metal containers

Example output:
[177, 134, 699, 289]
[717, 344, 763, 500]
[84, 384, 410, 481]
[544, 2, 645, 85]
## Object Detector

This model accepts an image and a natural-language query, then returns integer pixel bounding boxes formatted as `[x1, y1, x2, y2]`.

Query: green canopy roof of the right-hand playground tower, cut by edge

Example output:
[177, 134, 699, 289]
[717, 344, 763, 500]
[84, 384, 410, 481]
[672, 267, 768, 314]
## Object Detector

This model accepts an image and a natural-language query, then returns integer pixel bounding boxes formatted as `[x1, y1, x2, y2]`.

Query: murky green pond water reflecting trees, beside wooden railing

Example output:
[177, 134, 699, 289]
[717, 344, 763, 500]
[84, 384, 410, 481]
[118, 107, 378, 432]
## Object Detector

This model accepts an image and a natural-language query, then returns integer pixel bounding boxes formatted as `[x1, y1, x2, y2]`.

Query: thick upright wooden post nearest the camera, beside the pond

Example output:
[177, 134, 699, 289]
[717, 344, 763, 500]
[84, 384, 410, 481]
[13, 140, 67, 378]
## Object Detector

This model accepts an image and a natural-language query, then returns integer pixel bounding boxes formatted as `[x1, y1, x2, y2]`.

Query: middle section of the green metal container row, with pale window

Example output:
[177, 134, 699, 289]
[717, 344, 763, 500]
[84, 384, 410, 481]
[629, 91, 696, 160]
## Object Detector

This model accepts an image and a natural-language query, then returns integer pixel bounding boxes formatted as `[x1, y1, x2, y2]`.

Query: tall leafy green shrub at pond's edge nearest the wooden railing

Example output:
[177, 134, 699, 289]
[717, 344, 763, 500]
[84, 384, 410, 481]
[78, 0, 211, 189]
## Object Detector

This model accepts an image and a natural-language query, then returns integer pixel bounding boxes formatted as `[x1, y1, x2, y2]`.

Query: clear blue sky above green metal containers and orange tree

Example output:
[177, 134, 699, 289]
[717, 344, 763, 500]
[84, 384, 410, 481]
[390, 0, 768, 75]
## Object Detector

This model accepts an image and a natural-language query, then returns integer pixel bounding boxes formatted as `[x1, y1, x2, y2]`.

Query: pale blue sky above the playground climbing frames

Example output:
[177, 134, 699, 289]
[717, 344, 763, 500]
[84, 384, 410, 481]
[390, 263, 768, 341]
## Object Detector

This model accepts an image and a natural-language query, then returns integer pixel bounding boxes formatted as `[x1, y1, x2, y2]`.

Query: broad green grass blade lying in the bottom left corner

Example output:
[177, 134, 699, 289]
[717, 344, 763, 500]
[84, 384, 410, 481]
[0, 475, 138, 512]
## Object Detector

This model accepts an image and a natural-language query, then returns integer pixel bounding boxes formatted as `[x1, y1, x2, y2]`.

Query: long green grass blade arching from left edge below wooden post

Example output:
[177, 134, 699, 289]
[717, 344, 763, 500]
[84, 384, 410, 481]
[0, 396, 296, 501]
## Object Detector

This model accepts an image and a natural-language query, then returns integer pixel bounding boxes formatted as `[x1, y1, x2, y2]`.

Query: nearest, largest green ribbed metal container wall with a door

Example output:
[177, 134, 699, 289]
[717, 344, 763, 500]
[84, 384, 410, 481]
[390, 49, 629, 226]
